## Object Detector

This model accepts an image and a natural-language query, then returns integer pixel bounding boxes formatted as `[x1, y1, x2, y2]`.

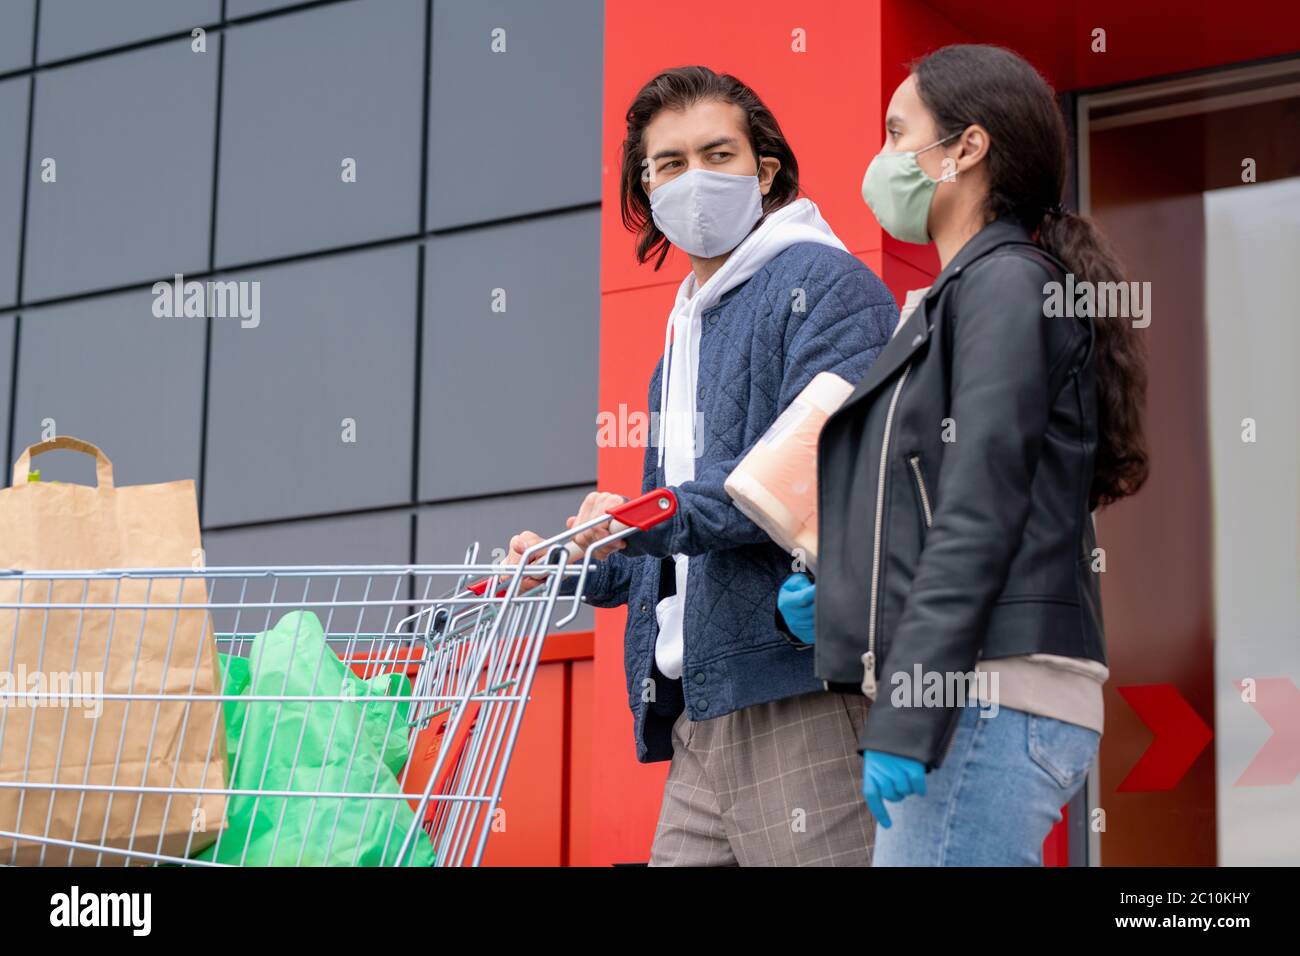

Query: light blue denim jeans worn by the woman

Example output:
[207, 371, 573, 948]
[872, 706, 1101, 866]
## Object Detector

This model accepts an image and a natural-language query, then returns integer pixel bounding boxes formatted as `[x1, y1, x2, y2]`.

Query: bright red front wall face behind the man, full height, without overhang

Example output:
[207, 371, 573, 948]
[592, 0, 883, 865]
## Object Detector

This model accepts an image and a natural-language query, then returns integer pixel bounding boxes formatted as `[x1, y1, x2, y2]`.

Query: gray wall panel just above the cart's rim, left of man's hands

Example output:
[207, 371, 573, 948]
[416, 485, 595, 631]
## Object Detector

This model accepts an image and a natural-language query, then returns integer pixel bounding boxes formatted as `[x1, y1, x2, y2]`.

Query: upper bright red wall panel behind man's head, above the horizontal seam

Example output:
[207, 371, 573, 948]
[601, 0, 881, 297]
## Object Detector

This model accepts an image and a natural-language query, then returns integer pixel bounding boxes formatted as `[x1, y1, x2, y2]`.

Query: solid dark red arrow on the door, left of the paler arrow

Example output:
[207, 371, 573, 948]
[1117, 684, 1214, 793]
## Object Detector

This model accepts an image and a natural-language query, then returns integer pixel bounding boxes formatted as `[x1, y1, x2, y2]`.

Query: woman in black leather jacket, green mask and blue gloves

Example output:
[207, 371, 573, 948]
[779, 46, 1147, 866]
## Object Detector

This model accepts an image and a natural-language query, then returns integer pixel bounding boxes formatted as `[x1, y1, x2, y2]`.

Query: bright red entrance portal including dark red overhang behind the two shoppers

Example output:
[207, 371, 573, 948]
[589, 0, 1300, 865]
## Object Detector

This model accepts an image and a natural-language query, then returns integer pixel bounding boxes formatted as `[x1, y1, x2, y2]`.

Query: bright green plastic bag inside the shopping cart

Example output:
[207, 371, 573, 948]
[195, 611, 434, 866]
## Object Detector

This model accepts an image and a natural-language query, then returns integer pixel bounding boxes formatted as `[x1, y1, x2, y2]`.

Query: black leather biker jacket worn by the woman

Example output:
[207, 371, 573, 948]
[815, 220, 1105, 767]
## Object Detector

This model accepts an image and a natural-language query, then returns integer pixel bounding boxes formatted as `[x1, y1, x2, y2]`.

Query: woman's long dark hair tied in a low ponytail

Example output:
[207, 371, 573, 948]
[911, 44, 1149, 507]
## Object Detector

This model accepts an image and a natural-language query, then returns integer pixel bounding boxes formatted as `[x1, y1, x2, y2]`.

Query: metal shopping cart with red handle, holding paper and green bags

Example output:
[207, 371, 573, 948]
[0, 489, 676, 866]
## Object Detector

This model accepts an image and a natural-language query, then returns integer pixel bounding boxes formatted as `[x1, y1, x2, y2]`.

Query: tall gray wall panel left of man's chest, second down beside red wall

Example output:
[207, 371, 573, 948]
[420, 212, 599, 501]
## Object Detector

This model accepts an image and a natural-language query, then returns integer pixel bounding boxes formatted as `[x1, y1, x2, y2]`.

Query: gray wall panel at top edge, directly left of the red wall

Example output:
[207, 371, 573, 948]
[429, 0, 605, 229]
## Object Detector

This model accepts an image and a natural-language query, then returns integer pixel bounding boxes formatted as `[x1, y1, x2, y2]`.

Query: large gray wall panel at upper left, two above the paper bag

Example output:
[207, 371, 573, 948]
[23, 38, 218, 302]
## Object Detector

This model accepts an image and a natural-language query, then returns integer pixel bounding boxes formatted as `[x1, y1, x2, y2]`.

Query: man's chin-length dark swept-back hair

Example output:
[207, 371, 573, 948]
[619, 66, 800, 269]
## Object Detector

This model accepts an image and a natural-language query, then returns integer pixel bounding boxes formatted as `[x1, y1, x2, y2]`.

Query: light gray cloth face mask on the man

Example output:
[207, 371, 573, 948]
[650, 169, 763, 259]
